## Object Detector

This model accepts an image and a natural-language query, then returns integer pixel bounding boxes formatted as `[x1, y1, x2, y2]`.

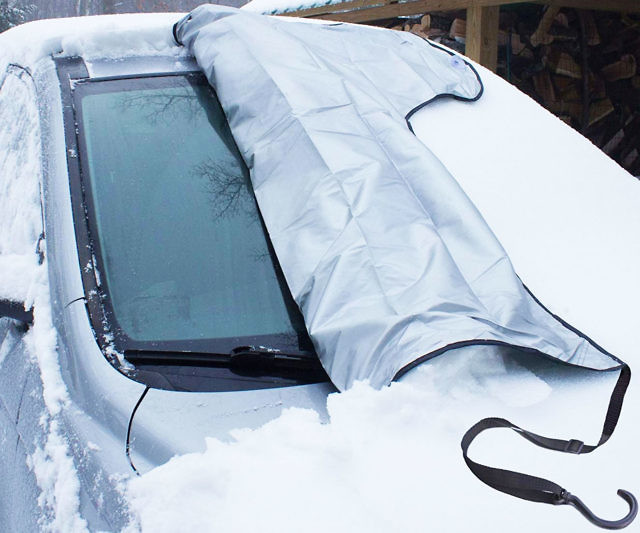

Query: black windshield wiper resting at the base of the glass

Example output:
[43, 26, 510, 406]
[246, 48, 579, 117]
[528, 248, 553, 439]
[124, 346, 326, 378]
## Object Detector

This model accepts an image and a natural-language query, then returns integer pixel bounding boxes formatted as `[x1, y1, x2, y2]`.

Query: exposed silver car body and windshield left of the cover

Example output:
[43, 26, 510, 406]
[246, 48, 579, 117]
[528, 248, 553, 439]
[0, 16, 334, 531]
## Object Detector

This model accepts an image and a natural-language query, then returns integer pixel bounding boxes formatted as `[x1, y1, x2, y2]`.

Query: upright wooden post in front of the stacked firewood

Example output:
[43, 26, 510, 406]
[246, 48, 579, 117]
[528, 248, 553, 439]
[465, 4, 500, 72]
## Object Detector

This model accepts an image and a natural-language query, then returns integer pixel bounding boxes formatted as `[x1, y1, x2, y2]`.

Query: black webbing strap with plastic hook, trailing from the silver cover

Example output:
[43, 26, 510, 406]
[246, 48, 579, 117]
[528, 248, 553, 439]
[461, 364, 637, 528]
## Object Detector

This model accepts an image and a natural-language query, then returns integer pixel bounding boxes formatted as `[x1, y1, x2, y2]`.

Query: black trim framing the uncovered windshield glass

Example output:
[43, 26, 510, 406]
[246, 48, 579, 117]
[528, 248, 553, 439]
[56, 60, 328, 391]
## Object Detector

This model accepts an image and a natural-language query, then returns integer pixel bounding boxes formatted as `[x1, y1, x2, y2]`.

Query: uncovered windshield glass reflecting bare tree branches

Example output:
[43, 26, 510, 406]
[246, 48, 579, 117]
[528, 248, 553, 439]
[76, 75, 310, 353]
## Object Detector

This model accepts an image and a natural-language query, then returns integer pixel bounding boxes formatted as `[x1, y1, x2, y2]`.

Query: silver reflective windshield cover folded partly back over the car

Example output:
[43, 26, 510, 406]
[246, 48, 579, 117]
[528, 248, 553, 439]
[175, 5, 620, 390]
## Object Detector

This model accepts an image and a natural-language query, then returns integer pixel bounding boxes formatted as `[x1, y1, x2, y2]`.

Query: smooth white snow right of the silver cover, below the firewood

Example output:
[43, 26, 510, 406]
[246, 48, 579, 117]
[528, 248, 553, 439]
[412, 66, 640, 362]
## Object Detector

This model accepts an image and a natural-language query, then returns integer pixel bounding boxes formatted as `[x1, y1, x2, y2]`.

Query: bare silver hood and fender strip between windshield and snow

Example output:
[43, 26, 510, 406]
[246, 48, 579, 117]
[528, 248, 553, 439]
[58, 300, 336, 474]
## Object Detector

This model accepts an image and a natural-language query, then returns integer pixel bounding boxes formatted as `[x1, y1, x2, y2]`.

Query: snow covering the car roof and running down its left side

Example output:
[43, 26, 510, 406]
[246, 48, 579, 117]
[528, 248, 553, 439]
[0, 13, 191, 532]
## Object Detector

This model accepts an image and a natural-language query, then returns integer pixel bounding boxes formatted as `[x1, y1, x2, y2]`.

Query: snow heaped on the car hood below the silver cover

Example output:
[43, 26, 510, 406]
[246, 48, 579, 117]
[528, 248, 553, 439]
[129, 342, 631, 532]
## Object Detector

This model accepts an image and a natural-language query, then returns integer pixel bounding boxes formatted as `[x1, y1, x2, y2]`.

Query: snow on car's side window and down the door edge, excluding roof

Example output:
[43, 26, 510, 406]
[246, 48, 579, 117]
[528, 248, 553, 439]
[0, 38, 87, 532]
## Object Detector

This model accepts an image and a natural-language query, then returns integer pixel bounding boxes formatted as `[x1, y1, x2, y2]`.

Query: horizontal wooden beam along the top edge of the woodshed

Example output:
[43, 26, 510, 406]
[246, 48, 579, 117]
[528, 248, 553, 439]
[281, 0, 640, 22]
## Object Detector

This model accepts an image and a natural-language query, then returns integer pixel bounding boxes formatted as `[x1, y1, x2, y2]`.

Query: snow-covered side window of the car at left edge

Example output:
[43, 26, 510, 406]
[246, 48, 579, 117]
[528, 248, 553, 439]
[0, 66, 43, 302]
